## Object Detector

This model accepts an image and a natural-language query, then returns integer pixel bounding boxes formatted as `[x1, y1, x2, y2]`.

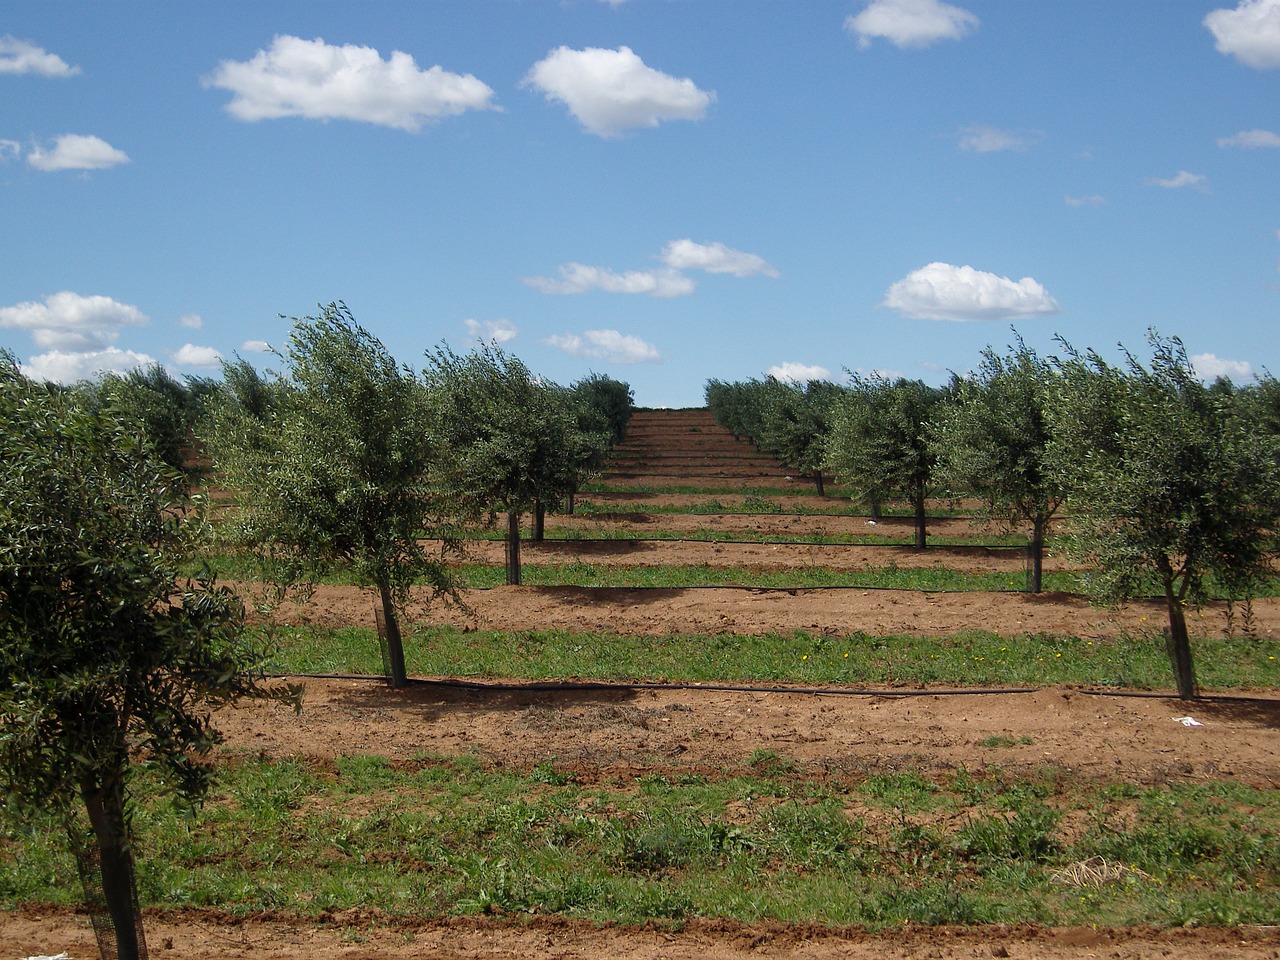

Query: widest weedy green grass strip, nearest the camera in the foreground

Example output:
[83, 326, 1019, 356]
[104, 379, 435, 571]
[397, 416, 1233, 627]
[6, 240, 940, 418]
[0, 751, 1280, 929]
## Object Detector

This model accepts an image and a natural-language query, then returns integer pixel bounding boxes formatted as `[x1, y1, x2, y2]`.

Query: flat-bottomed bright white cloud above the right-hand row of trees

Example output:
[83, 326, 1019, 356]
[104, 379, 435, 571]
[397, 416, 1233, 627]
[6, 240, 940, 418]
[881, 262, 1061, 320]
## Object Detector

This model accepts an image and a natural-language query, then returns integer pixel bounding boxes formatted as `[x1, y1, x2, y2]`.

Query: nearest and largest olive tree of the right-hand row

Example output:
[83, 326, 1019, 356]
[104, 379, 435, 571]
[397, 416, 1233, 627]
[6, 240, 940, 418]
[1047, 332, 1280, 699]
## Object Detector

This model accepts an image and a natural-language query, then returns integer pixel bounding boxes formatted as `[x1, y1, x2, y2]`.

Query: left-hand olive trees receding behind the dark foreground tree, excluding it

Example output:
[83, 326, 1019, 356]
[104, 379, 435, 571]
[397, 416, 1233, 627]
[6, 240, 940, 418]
[205, 303, 632, 686]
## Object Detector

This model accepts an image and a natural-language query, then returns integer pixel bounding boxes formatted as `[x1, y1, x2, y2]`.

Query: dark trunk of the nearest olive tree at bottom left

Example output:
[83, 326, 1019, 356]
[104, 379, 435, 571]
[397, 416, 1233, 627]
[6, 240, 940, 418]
[81, 781, 147, 960]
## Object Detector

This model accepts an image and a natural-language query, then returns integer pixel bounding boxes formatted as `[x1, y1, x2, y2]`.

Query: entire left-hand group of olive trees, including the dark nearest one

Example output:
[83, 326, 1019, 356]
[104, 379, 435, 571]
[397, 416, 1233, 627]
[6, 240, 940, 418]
[0, 303, 631, 960]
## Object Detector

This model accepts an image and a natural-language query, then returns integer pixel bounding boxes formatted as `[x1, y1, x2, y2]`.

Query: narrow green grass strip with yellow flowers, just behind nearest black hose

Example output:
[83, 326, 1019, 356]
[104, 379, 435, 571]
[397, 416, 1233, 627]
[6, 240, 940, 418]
[254, 624, 1280, 690]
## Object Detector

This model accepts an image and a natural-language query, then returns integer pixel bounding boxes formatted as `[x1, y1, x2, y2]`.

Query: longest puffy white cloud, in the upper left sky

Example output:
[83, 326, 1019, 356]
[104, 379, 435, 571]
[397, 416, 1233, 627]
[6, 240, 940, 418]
[204, 36, 495, 132]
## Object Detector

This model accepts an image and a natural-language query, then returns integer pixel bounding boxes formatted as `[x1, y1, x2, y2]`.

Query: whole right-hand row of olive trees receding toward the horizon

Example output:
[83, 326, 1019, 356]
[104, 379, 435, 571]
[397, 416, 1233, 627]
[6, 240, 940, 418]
[707, 333, 1280, 698]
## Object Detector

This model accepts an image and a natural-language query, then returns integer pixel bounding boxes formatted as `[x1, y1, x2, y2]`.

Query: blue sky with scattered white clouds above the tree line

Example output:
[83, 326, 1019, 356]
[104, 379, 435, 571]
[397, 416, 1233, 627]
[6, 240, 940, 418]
[0, 0, 1280, 406]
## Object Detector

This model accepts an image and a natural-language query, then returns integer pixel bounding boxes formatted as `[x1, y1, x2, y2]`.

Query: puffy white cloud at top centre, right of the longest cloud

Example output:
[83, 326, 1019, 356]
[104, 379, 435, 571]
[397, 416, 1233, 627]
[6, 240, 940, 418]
[521, 46, 716, 137]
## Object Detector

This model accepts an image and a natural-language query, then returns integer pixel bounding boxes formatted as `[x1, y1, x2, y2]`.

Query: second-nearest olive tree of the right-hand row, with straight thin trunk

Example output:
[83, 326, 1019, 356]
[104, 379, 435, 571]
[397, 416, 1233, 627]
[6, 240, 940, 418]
[931, 339, 1064, 593]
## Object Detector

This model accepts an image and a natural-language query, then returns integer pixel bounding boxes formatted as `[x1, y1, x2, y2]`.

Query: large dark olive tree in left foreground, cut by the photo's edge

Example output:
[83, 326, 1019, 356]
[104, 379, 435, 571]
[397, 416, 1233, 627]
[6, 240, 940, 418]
[0, 356, 283, 960]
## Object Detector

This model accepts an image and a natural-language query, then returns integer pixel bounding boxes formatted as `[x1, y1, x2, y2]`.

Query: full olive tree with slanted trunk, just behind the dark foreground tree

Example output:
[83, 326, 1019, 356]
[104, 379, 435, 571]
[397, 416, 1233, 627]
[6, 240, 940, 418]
[209, 303, 457, 686]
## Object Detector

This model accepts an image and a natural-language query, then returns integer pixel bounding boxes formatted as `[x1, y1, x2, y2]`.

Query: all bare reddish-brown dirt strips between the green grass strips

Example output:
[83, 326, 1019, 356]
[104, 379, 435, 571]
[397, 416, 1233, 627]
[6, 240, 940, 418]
[12, 412, 1280, 960]
